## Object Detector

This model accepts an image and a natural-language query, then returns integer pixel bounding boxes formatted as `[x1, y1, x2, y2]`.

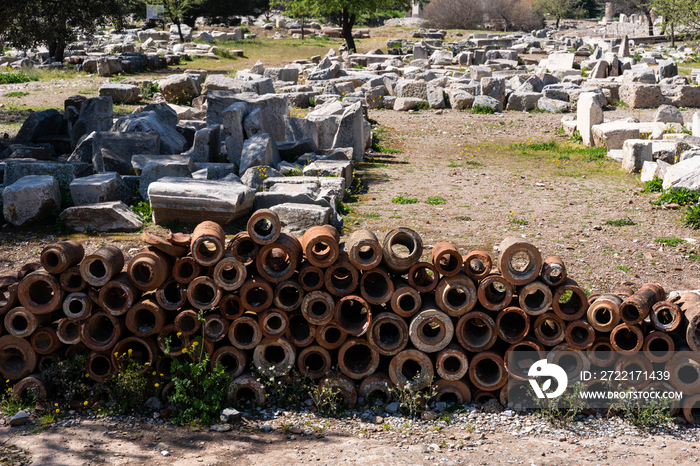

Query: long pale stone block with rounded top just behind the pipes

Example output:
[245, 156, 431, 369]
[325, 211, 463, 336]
[148, 178, 255, 225]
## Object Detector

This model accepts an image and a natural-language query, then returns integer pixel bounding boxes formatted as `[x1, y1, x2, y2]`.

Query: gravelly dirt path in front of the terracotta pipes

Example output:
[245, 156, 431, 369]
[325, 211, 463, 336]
[0, 416, 700, 466]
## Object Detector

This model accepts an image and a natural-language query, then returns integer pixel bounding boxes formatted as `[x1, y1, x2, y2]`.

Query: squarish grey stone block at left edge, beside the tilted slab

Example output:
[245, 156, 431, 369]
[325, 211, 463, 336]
[2, 174, 61, 226]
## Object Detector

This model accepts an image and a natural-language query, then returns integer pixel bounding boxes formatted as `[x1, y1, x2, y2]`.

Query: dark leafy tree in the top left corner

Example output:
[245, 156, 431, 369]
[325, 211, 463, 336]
[0, 0, 129, 61]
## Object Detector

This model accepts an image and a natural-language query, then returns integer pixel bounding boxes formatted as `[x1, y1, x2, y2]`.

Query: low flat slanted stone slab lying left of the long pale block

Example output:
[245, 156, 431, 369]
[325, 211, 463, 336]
[60, 201, 143, 232]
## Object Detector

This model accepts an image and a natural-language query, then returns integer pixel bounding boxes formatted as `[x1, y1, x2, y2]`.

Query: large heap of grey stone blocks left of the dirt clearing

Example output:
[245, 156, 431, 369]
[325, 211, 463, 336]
[0, 70, 372, 232]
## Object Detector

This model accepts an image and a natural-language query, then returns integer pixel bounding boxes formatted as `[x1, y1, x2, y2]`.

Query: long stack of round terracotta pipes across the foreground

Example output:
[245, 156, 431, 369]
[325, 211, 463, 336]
[0, 210, 700, 422]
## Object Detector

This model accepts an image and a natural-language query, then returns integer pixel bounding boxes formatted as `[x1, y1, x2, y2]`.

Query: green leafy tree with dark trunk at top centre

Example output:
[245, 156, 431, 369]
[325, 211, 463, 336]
[278, 0, 427, 52]
